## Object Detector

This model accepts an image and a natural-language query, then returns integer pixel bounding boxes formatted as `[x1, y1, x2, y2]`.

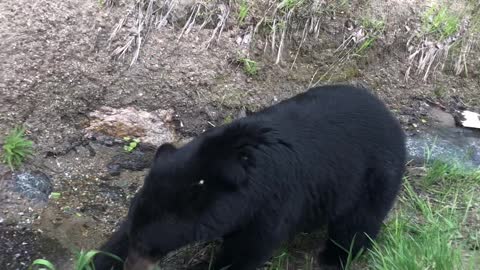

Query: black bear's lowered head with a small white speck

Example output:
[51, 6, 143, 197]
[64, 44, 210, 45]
[124, 124, 271, 270]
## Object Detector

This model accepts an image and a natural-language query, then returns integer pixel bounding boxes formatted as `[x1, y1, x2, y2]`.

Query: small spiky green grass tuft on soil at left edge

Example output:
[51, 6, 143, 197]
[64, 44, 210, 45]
[2, 127, 33, 170]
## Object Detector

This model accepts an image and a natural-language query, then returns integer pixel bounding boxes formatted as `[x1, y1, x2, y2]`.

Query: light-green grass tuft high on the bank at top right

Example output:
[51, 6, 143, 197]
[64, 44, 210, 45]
[422, 6, 461, 40]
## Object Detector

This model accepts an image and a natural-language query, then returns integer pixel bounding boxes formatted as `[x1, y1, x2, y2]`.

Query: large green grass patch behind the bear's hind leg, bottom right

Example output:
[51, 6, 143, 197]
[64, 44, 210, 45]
[368, 158, 480, 270]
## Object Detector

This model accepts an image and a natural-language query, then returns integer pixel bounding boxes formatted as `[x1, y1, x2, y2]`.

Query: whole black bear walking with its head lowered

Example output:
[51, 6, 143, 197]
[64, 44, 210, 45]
[95, 85, 406, 270]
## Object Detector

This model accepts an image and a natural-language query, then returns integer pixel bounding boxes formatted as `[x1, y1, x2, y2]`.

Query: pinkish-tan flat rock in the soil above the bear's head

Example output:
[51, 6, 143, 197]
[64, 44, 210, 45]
[86, 107, 175, 145]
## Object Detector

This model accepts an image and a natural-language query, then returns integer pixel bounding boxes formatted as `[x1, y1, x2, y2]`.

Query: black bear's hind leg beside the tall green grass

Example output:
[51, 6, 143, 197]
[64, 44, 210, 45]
[318, 209, 383, 269]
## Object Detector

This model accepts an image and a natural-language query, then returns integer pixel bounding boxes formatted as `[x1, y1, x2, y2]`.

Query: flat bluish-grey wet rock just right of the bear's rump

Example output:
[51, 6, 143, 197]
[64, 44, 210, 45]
[407, 128, 480, 167]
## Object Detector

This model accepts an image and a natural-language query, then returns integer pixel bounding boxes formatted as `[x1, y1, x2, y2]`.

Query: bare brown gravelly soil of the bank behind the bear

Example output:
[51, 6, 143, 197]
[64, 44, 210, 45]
[0, 0, 480, 269]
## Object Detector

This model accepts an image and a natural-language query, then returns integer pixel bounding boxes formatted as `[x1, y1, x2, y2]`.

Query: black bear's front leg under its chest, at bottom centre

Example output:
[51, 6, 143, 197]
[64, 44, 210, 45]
[213, 226, 281, 270]
